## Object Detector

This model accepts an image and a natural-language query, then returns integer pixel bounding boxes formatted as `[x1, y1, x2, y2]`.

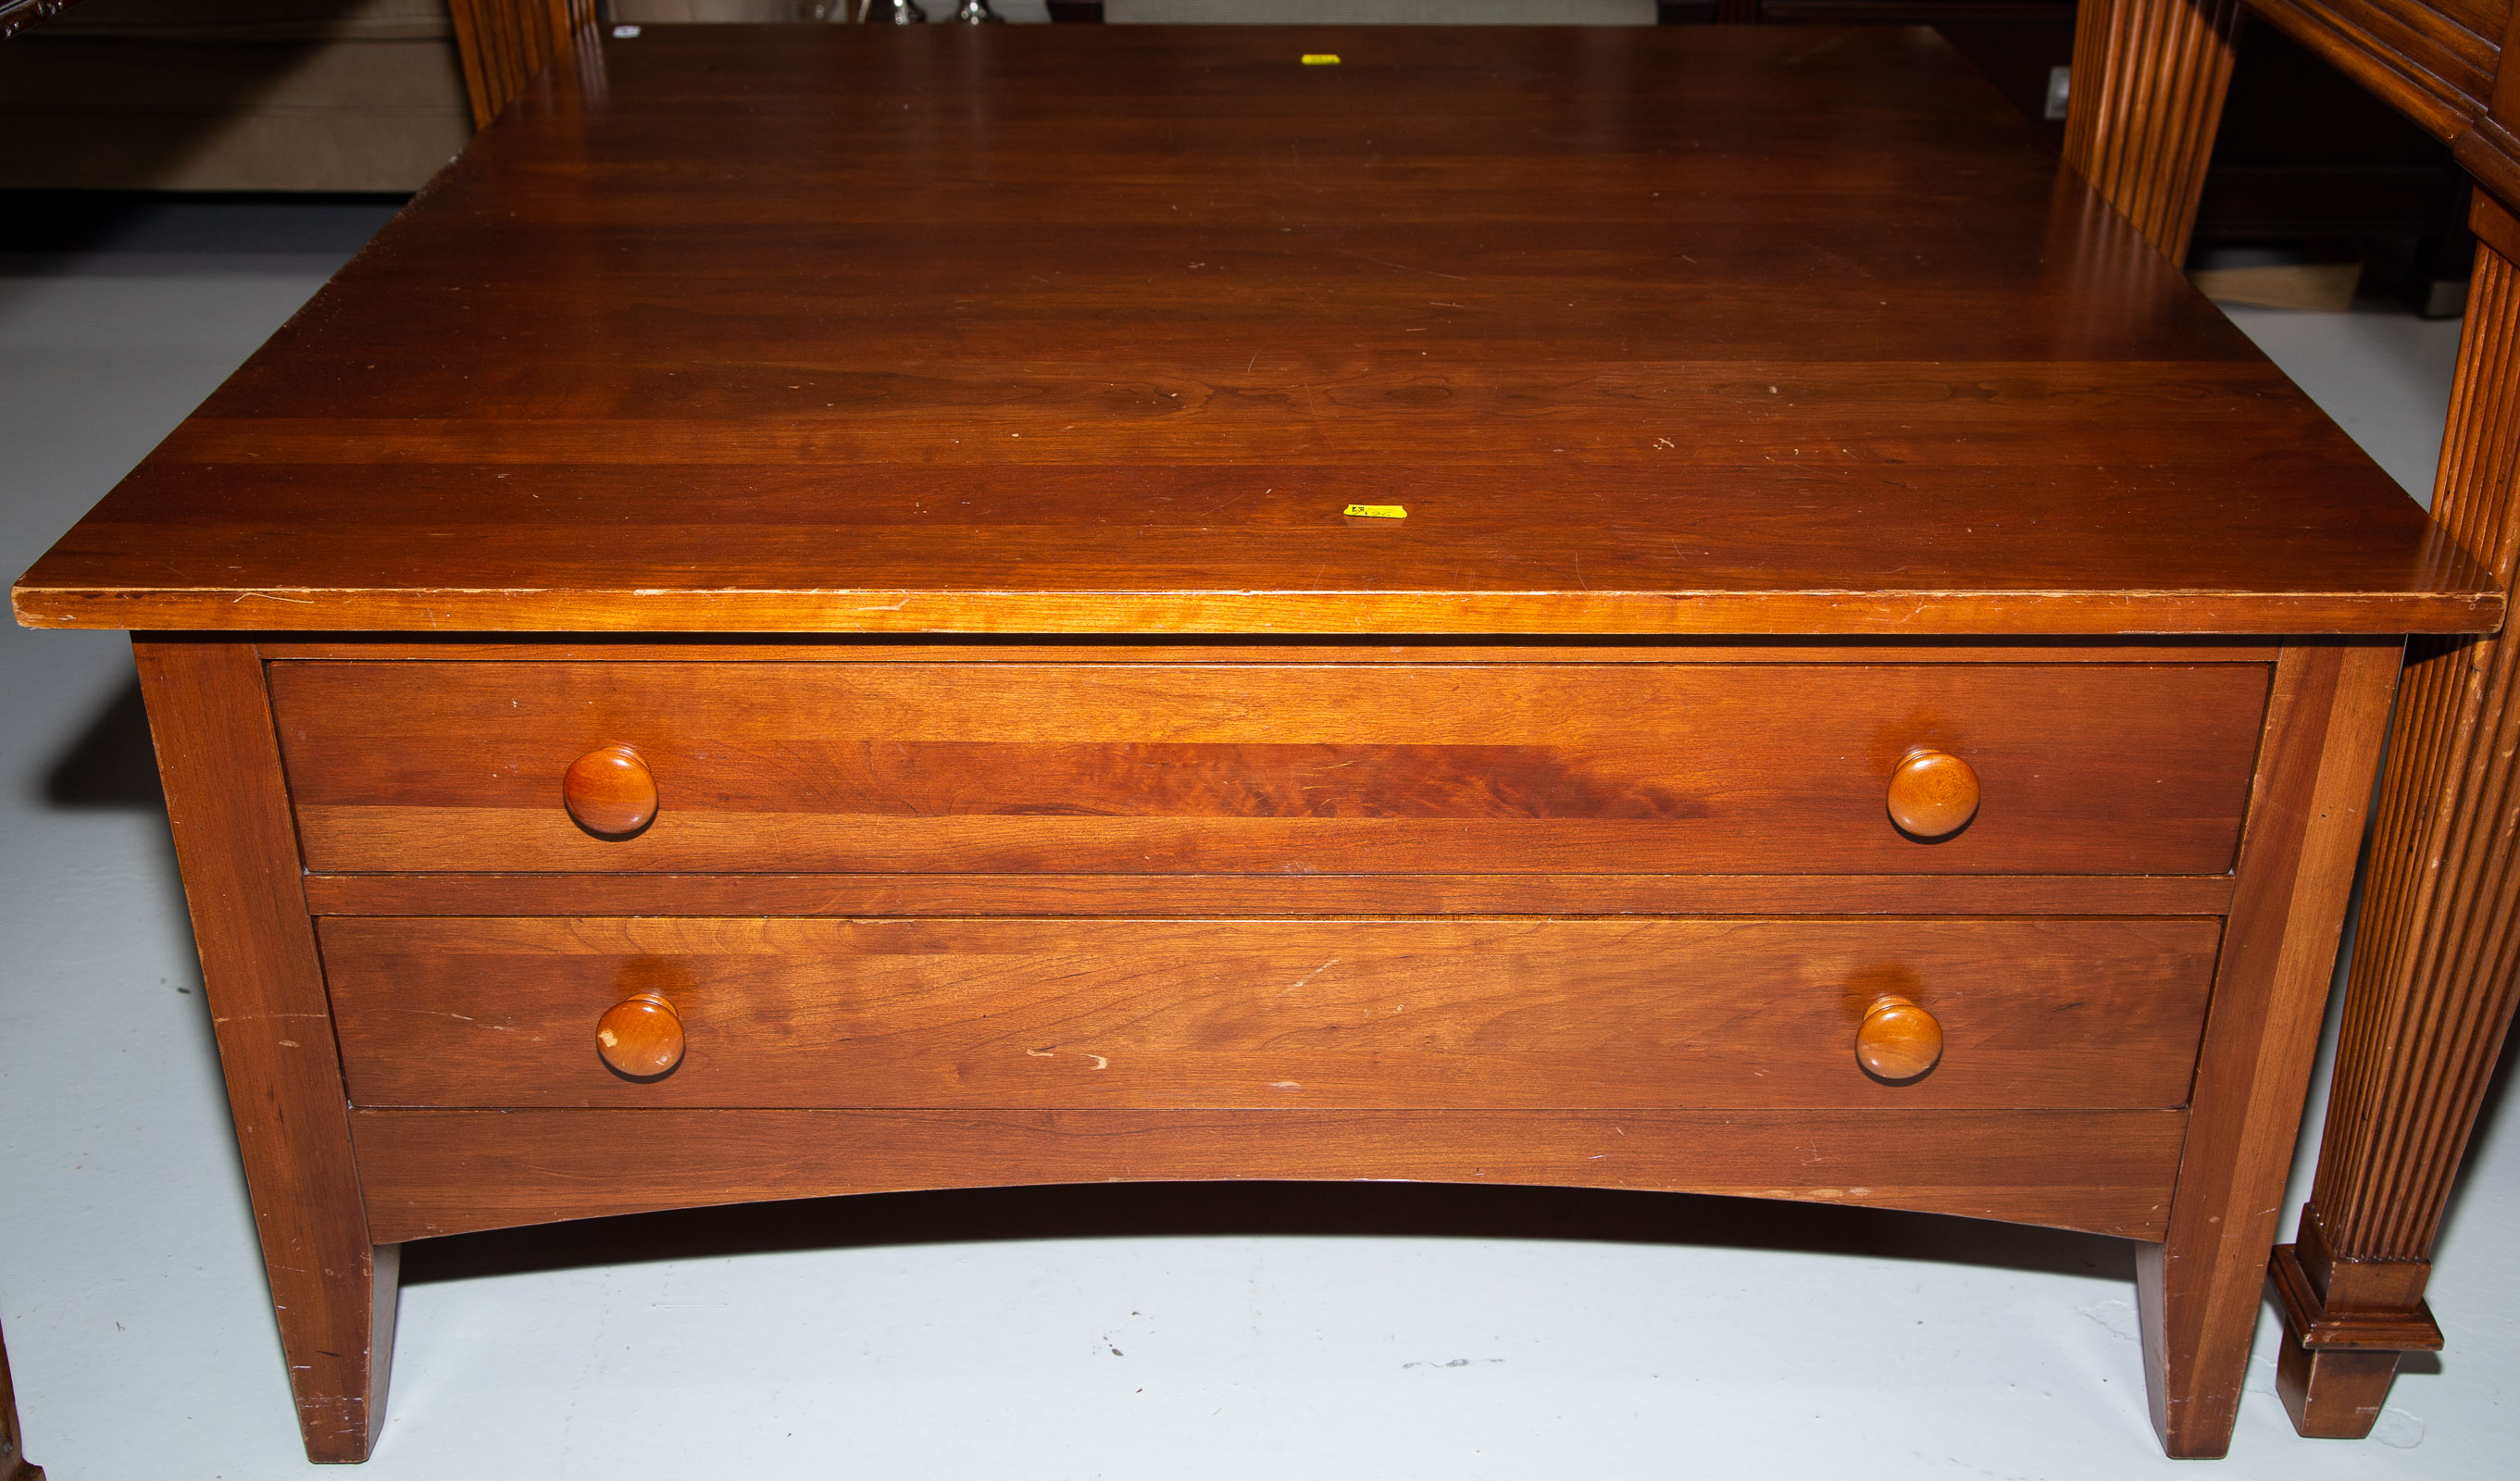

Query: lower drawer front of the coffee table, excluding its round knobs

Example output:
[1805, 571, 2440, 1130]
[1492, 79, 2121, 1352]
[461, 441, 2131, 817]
[320, 916, 2220, 1108]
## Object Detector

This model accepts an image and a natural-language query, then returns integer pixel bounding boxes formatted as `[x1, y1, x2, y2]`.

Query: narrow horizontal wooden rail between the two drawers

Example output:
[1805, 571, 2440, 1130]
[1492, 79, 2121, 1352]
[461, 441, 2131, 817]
[305, 874, 2233, 916]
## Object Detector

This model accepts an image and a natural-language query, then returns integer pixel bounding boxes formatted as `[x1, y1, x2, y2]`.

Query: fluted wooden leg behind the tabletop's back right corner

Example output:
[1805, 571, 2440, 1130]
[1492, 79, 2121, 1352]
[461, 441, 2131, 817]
[2064, 0, 2240, 262]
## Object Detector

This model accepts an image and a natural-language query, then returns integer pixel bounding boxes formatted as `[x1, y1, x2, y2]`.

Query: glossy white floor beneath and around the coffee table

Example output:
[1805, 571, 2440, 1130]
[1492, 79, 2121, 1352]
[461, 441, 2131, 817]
[0, 193, 2520, 1481]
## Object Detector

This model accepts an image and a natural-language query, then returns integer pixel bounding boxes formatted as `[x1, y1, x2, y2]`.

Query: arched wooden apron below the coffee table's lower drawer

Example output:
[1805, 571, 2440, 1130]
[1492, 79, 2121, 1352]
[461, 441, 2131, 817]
[350, 1111, 2188, 1239]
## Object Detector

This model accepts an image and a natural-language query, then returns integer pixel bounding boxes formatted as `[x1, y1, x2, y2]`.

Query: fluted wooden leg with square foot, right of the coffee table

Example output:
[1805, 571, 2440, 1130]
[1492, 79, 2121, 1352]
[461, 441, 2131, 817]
[2273, 192, 2520, 1438]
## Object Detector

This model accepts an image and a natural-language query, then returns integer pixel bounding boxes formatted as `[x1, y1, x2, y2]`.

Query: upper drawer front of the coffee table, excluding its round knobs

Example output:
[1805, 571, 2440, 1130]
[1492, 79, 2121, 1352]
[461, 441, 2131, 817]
[272, 660, 2268, 874]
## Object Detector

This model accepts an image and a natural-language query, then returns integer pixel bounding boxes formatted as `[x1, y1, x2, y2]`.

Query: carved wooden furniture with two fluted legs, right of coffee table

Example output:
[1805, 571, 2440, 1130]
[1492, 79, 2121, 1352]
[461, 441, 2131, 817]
[2069, 0, 2520, 1436]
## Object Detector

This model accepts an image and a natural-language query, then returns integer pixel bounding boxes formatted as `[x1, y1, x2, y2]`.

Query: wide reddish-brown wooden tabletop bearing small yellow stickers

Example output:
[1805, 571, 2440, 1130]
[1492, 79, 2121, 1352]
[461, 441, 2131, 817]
[15, 25, 2502, 635]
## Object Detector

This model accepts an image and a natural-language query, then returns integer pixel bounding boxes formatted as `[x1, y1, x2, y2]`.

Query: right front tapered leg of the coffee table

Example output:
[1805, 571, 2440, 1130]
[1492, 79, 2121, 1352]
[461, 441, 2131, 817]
[2137, 640, 2399, 1456]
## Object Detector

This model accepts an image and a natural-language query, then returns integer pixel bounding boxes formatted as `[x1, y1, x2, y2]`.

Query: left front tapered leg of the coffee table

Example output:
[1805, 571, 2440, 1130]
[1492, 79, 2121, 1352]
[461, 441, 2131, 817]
[133, 640, 395, 1461]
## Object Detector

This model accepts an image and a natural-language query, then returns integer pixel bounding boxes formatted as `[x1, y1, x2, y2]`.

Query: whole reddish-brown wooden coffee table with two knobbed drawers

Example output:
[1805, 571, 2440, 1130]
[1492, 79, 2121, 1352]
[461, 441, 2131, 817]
[15, 28, 2502, 1461]
